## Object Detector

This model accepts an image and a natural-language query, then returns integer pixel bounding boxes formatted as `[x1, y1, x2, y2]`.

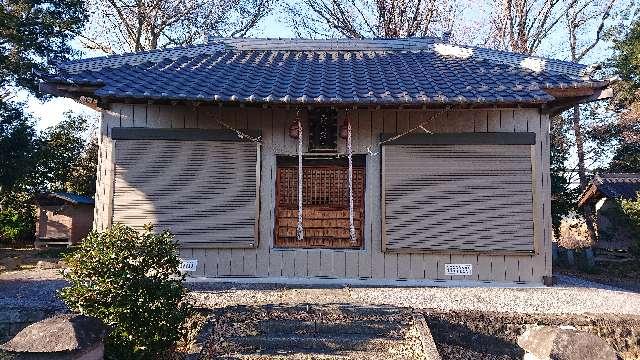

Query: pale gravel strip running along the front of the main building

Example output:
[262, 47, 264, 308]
[0, 270, 640, 316]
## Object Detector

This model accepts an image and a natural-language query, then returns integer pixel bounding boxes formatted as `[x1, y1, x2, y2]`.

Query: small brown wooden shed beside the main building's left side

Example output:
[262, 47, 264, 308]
[36, 192, 94, 245]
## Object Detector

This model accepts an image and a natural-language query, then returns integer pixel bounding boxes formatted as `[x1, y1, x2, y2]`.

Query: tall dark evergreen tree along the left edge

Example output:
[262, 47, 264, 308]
[0, 0, 86, 241]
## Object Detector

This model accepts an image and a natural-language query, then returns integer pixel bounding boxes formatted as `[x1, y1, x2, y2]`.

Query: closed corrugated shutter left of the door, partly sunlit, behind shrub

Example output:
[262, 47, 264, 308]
[113, 140, 258, 248]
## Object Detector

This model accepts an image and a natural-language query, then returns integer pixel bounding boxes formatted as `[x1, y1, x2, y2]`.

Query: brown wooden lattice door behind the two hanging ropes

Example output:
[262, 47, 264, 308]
[275, 158, 365, 249]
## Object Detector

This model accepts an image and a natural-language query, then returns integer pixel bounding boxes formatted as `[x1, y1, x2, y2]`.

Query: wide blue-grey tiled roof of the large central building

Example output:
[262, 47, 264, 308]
[46, 38, 606, 105]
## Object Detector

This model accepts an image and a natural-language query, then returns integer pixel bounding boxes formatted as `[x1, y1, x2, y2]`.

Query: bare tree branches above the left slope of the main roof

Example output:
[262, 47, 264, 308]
[77, 0, 274, 53]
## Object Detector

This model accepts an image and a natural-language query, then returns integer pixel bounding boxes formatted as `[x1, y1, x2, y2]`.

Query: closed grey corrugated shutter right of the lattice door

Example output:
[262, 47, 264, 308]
[383, 145, 534, 252]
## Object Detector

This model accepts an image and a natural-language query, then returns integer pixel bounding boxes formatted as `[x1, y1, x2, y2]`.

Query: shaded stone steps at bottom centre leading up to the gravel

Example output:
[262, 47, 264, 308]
[199, 306, 421, 360]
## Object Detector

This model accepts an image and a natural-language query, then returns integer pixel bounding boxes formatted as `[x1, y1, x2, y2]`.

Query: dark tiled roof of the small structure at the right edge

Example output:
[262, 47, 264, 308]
[578, 173, 640, 206]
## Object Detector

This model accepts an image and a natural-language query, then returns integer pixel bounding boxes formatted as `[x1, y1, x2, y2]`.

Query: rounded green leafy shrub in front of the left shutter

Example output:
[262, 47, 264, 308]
[60, 224, 192, 359]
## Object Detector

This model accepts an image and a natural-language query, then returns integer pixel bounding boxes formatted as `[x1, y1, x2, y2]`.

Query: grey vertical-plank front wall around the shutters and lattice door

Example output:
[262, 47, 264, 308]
[94, 104, 551, 283]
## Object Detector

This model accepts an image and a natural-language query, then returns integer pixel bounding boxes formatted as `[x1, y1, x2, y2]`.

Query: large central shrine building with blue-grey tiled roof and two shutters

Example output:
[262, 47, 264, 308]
[41, 38, 610, 285]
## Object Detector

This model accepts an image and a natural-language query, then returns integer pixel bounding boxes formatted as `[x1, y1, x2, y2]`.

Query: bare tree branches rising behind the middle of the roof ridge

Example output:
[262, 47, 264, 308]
[287, 0, 480, 38]
